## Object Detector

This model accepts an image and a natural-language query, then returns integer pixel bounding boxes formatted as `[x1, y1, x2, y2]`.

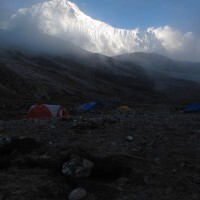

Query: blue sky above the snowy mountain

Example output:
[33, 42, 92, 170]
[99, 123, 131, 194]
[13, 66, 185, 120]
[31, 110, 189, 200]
[0, 0, 200, 34]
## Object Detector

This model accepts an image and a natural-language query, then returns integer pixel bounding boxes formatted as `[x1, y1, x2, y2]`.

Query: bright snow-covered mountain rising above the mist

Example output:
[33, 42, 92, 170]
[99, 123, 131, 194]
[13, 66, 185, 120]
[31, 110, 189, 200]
[0, 0, 179, 56]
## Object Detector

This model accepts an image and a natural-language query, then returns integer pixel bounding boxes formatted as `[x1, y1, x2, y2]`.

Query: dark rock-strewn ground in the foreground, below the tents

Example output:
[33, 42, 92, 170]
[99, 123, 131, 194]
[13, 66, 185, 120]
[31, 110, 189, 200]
[0, 106, 200, 200]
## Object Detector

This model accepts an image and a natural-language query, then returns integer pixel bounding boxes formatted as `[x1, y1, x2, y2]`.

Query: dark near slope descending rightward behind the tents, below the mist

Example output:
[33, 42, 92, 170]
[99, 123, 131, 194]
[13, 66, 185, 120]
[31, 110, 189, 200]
[0, 48, 200, 104]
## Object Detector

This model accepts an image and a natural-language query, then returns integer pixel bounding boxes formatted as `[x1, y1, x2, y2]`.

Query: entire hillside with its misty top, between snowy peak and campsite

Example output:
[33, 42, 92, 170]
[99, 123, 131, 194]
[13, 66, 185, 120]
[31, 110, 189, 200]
[0, 28, 200, 106]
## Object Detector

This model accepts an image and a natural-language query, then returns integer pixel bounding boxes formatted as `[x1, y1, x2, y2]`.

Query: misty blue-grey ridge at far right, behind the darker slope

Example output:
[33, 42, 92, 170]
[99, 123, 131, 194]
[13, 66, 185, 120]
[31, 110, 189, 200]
[115, 52, 200, 82]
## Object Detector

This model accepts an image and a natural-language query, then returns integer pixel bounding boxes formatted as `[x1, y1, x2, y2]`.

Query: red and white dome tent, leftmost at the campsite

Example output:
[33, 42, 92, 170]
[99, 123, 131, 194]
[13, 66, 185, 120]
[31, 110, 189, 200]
[25, 104, 69, 119]
